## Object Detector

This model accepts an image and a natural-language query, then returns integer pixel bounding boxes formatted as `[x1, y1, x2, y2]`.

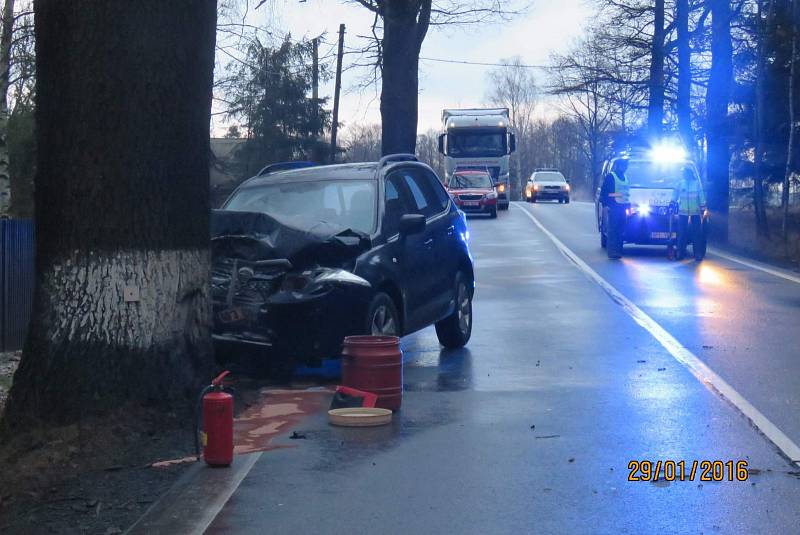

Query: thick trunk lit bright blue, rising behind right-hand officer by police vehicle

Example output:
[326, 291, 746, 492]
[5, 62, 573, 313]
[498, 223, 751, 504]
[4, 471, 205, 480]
[706, 0, 733, 241]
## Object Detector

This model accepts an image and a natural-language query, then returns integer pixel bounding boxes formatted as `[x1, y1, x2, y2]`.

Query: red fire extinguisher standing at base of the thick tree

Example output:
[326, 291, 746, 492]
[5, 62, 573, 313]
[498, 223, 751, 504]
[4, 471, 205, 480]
[195, 371, 233, 466]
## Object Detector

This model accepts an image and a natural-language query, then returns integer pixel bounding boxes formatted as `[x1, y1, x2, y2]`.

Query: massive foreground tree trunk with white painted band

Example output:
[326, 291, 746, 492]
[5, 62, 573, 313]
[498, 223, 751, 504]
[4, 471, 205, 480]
[1, 0, 216, 428]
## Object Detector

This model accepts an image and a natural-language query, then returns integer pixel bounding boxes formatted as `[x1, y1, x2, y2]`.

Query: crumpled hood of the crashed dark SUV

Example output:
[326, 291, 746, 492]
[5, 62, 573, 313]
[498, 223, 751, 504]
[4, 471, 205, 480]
[211, 210, 370, 268]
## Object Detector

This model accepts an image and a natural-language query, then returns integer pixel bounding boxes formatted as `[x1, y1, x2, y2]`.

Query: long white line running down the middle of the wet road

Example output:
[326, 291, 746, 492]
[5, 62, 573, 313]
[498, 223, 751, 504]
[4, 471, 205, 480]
[515, 206, 800, 466]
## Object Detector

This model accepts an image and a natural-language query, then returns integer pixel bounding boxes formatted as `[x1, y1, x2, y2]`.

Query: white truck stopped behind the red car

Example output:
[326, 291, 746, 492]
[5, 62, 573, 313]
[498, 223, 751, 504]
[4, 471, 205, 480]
[439, 108, 517, 210]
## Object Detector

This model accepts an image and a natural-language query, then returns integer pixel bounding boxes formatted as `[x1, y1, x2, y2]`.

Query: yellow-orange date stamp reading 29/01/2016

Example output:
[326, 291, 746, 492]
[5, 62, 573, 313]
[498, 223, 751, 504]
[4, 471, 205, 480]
[628, 460, 750, 482]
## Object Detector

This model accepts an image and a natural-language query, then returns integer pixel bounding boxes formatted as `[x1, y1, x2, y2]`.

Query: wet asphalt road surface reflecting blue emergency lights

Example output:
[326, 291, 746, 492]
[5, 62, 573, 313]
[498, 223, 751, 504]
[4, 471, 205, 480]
[207, 203, 800, 534]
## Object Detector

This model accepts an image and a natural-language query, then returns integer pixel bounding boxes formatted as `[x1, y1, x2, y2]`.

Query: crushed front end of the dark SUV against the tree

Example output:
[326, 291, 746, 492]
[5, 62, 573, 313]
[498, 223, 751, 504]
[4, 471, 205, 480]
[211, 210, 370, 362]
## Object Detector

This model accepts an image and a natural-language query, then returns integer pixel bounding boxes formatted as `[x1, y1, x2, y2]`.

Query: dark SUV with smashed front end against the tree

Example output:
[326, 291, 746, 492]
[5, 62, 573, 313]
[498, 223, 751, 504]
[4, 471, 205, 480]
[212, 155, 475, 370]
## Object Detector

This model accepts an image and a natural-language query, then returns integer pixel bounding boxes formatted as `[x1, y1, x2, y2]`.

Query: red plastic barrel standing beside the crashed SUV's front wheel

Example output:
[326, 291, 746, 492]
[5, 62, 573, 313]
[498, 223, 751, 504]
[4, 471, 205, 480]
[342, 336, 403, 411]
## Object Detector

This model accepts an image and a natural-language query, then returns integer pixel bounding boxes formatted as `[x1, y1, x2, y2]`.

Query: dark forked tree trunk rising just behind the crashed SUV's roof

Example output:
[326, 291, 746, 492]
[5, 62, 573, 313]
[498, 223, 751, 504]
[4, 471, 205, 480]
[381, 0, 431, 155]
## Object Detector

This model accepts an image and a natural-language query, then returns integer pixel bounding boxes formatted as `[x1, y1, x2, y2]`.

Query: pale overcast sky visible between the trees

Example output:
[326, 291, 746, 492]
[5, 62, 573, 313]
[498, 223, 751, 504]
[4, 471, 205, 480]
[216, 0, 591, 138]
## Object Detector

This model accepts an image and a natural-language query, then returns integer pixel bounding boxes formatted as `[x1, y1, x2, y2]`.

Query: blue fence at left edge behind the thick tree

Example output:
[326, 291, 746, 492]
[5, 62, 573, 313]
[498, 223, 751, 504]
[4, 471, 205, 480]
[0, 219, 35, 351]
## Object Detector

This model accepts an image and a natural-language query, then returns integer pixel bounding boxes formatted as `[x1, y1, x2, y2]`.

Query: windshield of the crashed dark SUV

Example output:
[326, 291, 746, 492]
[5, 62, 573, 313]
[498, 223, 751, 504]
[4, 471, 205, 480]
[225, 180, 377, 234]
